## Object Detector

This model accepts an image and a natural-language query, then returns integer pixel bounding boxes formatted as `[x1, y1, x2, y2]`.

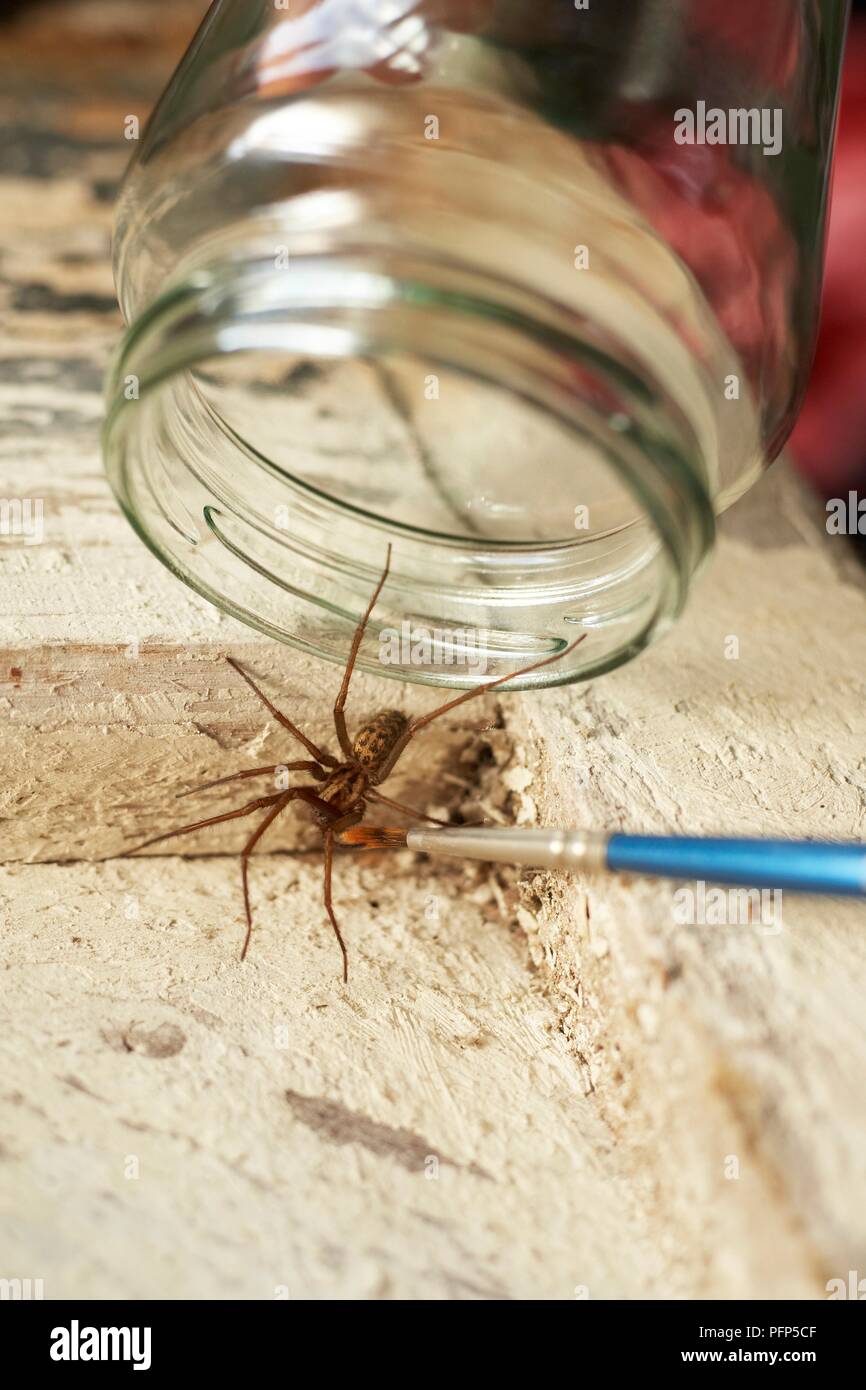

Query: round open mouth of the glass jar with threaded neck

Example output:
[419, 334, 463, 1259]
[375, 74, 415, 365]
[104, 245, 714, 689]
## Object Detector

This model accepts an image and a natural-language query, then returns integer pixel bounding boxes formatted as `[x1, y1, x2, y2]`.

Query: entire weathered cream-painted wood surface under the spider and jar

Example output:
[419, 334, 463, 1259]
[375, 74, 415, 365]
[0, 6, 866, 1298]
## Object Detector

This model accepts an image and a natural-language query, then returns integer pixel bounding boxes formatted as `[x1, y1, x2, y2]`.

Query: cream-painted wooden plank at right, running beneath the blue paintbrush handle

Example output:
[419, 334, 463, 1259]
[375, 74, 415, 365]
[509, 466, 866, 1298]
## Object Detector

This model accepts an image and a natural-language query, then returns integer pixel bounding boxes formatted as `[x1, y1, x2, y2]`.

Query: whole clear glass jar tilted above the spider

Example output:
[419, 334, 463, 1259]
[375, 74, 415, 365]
[104, 0, 847, 685]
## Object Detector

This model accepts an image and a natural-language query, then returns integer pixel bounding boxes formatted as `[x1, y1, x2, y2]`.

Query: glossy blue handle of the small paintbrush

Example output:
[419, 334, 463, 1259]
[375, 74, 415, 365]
[606, 834, 866, 897]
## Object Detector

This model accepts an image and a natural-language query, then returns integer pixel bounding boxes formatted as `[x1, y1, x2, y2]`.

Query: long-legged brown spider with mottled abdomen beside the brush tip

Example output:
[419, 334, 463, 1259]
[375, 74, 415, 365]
[126, 546, 587, 981]
